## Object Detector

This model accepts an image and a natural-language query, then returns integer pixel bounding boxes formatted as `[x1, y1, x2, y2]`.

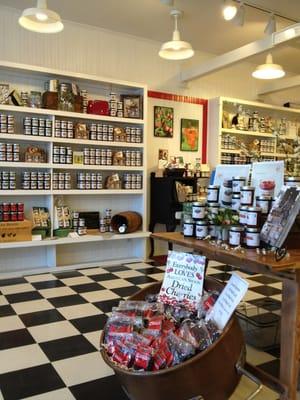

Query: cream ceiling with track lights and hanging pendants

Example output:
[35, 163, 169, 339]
[0, 0, 300, 73]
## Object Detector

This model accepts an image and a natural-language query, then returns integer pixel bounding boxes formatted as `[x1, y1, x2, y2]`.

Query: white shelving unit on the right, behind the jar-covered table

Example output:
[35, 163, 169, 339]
[208, 97, 300, 167]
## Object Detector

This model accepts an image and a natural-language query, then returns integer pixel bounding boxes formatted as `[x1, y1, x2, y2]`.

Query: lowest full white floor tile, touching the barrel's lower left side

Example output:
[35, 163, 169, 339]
[52, 351, 113, 388]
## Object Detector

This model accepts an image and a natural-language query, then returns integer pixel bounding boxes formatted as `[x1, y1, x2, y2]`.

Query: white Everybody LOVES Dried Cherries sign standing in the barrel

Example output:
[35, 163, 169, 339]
[158, 251, 206, 310]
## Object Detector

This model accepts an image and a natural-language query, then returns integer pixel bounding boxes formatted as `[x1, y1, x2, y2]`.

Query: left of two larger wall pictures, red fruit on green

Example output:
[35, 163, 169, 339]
[154, 106, 174, 138]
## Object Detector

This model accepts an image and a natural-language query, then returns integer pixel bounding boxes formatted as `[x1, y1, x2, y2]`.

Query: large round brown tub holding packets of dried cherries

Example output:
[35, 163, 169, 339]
[101, 278, 245, 400]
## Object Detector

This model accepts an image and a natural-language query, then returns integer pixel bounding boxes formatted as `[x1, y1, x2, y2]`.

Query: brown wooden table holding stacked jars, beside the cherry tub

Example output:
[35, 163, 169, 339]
[151, 232, 300, 400]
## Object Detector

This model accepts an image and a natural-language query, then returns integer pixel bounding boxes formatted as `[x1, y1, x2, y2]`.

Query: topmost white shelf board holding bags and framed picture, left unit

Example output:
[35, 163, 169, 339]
[0, 104, 145, 125]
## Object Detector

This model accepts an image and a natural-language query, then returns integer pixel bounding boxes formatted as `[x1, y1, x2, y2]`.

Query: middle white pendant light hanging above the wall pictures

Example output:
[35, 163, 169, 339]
[158, 10, 195, 60]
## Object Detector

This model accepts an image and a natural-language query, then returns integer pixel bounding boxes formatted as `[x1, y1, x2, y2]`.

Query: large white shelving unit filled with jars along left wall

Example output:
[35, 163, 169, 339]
[0, 61, 149, 274]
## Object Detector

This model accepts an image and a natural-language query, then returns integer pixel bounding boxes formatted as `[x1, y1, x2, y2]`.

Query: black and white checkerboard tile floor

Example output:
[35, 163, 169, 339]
[0, 263, 281, 400]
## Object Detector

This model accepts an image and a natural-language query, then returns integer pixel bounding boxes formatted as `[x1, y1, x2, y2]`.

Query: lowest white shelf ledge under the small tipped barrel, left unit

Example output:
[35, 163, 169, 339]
[0, 231, 150, 250]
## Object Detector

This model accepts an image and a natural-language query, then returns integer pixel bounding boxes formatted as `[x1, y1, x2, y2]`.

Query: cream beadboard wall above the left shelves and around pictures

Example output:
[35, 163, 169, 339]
[0, 6, 264, 252]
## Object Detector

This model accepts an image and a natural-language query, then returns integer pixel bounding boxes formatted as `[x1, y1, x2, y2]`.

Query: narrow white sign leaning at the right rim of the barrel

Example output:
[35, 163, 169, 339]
[207, 273, 249, 330]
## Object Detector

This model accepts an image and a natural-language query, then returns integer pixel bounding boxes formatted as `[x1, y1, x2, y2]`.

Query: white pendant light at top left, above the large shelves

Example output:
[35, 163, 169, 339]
[19, 0, 64, 33]
